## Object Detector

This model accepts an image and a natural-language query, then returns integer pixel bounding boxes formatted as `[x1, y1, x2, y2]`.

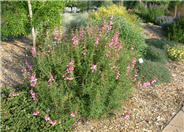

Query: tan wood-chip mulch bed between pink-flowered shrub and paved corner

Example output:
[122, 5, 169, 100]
[75, 62, 184, 132]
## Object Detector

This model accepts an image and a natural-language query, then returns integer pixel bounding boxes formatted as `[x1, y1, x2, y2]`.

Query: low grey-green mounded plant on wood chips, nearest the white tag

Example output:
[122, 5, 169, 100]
[136, 60, 172, 83]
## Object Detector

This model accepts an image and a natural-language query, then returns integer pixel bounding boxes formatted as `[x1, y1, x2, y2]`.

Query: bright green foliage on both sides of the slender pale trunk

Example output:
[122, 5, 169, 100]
[2, 1, 65, 40]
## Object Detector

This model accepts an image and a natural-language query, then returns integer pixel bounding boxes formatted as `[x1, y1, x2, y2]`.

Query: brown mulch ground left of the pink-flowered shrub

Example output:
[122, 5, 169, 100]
[0, 38, 31, 87]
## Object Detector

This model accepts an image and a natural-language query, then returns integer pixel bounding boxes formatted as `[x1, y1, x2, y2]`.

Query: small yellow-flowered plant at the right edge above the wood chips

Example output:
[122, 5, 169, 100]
[167, 47, 184, 61]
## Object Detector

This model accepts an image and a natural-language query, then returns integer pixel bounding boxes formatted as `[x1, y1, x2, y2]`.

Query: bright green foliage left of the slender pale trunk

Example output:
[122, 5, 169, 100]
[1, 2, 31, 40]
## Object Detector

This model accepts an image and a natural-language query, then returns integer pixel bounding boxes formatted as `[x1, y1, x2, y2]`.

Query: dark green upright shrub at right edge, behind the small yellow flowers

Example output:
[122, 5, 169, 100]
[164, 17, 184, 42]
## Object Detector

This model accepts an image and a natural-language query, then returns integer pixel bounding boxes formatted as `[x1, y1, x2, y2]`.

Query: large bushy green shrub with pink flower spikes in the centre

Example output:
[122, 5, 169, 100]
[22, 16, 136, 130]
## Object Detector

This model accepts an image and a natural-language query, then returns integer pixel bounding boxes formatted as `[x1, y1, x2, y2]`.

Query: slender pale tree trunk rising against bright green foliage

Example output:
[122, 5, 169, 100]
[28, 0, 36, 49]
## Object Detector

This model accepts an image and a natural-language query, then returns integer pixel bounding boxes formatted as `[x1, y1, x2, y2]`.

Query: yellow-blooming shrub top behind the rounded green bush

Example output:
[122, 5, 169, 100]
[89, 4, 140, 29]
